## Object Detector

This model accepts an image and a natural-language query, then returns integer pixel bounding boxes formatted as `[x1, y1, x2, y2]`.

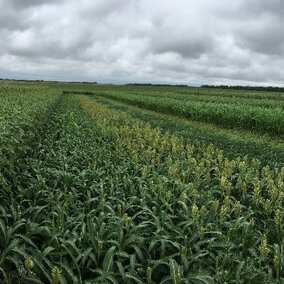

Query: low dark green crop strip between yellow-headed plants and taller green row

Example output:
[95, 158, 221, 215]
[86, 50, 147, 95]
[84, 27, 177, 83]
[90, 96, 284, 168]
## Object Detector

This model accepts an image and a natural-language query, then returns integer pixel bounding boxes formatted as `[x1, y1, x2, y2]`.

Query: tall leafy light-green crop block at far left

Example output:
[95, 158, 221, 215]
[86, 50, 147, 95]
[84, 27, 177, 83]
[0, 87, 57, 189]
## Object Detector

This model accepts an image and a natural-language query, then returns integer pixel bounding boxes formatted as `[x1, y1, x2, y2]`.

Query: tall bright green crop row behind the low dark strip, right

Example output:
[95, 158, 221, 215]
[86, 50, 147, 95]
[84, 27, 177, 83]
[74, 92, 284, 137]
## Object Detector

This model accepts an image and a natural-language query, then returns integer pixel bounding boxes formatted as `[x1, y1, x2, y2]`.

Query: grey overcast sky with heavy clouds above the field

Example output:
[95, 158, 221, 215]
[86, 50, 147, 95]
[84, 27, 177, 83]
[0, 0, 284, 85]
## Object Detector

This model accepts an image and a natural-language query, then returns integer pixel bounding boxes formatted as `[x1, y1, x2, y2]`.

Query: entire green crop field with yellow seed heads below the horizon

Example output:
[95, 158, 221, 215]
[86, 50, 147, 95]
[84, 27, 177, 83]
[0, 81, 284, 284]
